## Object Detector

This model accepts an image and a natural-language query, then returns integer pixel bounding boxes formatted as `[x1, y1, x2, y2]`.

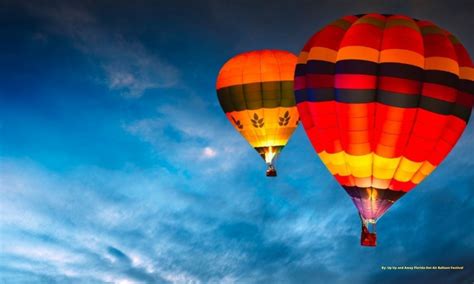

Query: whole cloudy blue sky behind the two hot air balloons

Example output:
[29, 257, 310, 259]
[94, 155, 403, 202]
[0, 0, 474, 283]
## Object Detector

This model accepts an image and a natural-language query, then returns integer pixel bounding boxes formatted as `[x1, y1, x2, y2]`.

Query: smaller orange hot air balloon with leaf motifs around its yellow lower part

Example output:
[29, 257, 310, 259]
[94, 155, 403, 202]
[216, 50, 299, 176]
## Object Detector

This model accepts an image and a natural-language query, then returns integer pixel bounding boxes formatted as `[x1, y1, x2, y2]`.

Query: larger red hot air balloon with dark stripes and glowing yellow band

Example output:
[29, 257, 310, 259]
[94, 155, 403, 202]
[295, 14, 474, 246]
